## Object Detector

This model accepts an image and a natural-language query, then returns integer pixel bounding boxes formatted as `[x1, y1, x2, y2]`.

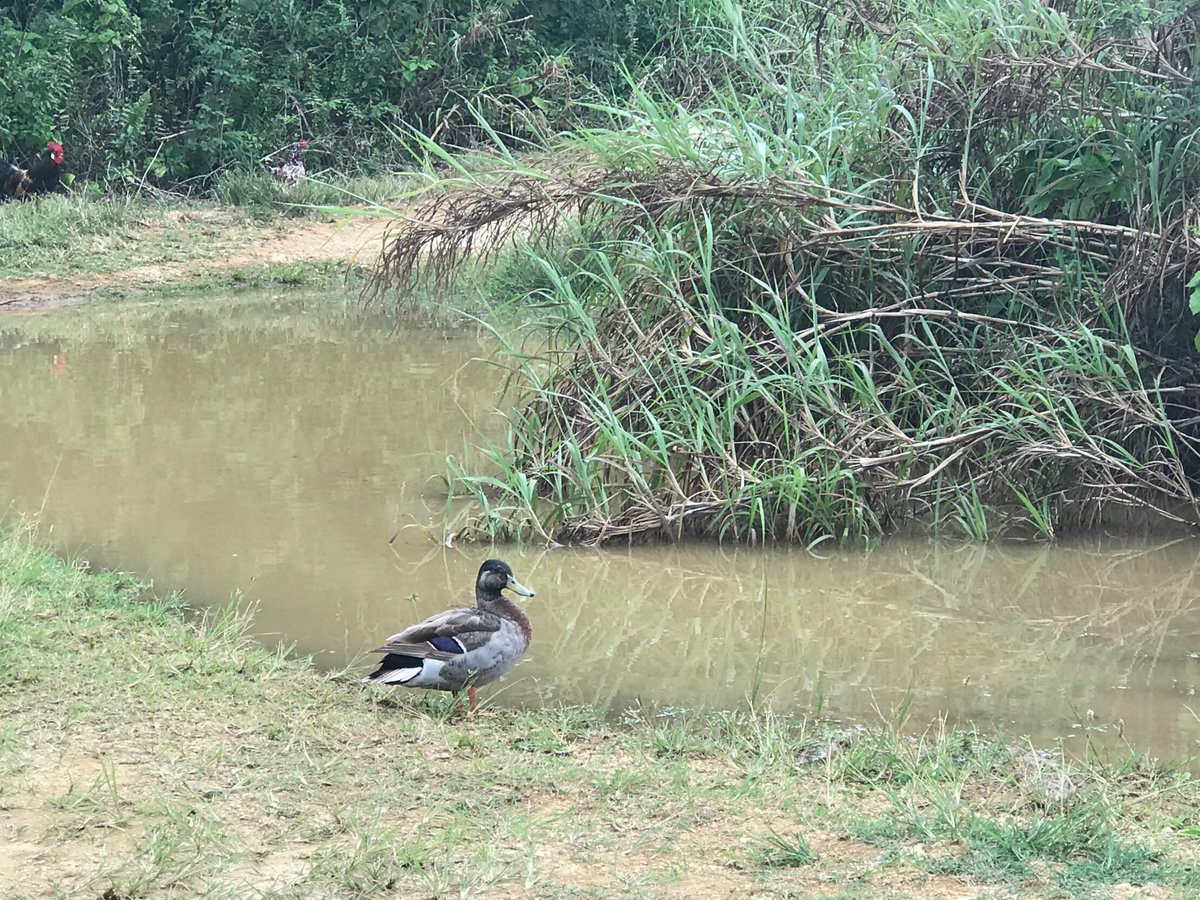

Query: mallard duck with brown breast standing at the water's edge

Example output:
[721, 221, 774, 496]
[362, 559, 533, 712]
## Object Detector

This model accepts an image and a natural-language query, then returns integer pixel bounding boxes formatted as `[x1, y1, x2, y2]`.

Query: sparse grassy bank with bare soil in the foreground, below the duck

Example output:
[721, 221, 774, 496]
[0, 525, 1200, 898]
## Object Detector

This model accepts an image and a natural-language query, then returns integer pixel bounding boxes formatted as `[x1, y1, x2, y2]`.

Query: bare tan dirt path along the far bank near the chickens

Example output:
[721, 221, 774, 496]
[0, 210, 392, 312]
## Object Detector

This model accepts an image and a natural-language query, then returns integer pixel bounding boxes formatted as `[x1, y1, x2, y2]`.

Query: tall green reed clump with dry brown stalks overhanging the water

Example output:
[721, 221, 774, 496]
[379, 0, 1200, 544]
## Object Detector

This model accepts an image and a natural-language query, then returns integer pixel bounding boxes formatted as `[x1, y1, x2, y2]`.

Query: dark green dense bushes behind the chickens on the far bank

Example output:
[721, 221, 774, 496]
[0, 0, 692, 185]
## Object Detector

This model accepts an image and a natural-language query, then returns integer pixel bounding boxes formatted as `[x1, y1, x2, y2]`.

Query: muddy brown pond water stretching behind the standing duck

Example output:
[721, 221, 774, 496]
[0, 301, 1200, 757]
